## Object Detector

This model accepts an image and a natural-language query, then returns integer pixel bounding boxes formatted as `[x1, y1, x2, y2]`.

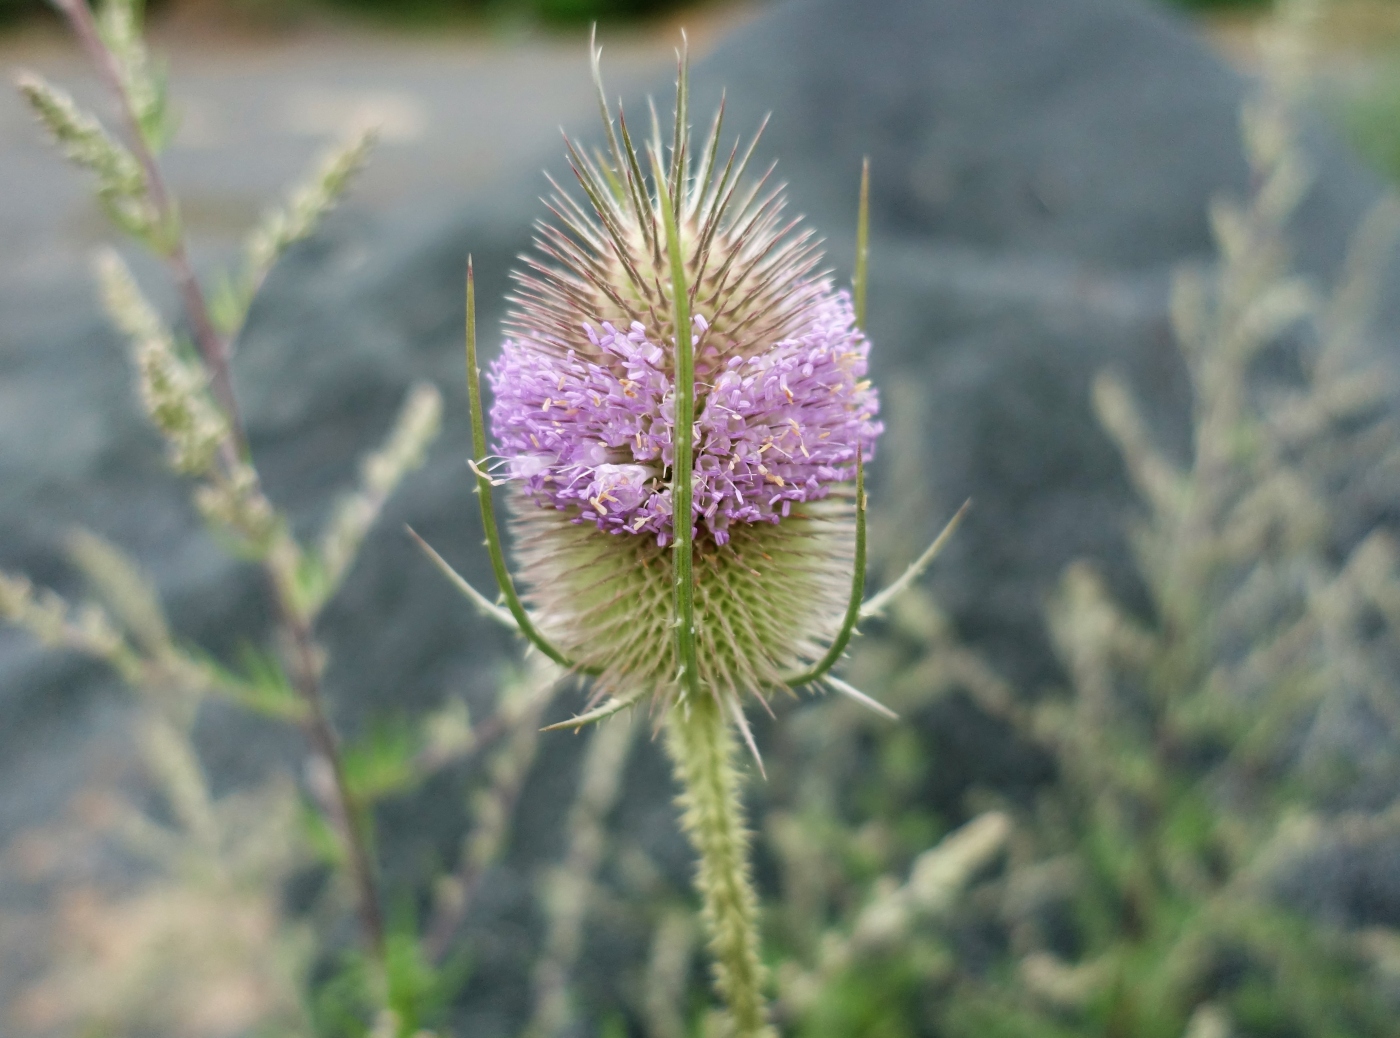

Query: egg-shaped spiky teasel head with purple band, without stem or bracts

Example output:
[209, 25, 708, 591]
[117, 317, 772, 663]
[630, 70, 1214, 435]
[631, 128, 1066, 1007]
[490, 56, 882, 703]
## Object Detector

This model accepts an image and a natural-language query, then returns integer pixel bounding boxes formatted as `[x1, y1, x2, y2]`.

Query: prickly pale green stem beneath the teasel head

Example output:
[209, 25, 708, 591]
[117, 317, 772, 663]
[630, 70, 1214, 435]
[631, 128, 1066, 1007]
[666, 695, 773, 1038]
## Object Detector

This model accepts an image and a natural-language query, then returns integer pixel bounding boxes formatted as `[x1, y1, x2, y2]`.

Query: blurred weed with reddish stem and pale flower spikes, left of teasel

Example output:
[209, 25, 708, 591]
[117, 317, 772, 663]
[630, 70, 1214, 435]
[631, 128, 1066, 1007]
[0, 0, 477, 1034]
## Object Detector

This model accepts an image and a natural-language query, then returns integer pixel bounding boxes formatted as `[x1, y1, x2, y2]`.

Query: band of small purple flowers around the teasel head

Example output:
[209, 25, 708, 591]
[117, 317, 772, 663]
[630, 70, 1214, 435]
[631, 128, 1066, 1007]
[490, 282, 882, 545]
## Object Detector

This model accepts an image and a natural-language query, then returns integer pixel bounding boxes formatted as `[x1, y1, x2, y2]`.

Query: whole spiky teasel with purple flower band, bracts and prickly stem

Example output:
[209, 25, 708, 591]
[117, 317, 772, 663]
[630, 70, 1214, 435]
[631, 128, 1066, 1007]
[411, 38, 962, 1038]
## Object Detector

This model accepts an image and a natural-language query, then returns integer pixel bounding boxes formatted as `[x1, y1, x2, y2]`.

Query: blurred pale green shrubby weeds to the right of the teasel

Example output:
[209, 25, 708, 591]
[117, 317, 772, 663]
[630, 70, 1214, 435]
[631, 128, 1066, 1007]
[760, 82, 1400, 1038]
